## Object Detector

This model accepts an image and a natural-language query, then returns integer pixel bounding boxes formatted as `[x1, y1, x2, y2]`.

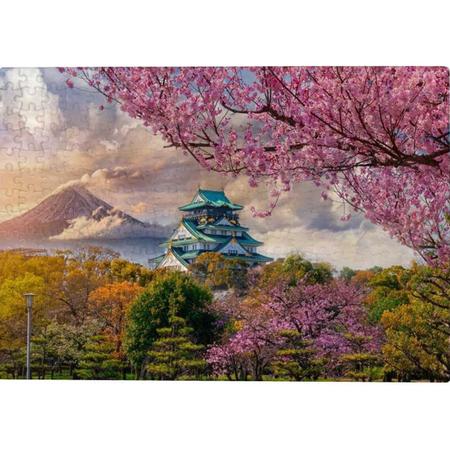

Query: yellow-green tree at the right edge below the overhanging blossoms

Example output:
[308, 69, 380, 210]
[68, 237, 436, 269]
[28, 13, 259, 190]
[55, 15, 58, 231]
[381, 265, 450, 381]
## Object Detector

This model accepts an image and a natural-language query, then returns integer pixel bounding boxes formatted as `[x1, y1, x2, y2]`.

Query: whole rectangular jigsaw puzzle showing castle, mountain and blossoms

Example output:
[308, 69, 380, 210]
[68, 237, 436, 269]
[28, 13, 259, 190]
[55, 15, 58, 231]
[0, 67, 450, 381]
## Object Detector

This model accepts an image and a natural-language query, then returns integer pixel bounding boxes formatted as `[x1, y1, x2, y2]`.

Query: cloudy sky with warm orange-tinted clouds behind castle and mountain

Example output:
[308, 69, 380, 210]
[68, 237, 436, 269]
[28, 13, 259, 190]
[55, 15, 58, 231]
[0, 68, 414, 269]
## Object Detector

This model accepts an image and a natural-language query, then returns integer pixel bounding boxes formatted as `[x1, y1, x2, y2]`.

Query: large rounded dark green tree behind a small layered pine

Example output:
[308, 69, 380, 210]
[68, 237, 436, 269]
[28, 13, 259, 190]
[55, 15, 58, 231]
[125, 271, 215, 377]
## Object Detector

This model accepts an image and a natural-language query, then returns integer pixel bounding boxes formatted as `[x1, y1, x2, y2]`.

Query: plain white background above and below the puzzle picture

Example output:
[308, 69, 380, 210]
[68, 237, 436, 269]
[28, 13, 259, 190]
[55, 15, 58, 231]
[0, 0, 450, 450]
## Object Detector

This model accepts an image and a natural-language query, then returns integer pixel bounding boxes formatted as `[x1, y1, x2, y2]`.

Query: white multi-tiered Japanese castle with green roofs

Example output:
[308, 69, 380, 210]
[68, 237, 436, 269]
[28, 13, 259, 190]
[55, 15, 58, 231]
[149, 189, 272, 271]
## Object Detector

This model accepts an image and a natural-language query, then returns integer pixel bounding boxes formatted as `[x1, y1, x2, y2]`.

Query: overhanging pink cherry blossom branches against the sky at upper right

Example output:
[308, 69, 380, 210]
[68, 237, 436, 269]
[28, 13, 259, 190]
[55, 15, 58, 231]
[61, 67, 450, 259]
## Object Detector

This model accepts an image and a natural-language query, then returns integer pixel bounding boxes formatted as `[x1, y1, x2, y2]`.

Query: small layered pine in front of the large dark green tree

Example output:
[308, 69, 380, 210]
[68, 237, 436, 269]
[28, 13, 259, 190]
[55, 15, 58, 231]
[147, 316, 206, 380]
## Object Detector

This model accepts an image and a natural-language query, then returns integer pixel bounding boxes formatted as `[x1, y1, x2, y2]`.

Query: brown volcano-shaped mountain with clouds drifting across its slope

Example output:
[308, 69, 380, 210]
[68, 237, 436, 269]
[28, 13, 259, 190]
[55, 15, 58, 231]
[0, 185, 166, 240]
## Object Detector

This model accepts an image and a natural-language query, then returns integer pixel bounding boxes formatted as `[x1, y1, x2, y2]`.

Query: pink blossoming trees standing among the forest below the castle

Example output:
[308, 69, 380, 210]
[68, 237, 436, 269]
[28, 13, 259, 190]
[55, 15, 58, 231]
[207, 277, 382, 380]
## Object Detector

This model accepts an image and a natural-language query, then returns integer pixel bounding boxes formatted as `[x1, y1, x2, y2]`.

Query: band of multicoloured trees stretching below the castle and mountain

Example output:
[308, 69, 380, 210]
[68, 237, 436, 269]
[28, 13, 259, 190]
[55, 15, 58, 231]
[0, 247, 450, 382]
